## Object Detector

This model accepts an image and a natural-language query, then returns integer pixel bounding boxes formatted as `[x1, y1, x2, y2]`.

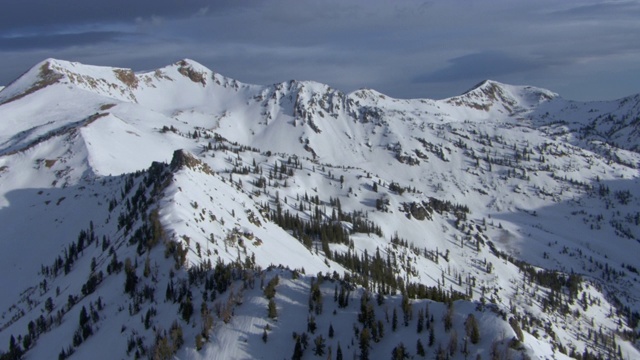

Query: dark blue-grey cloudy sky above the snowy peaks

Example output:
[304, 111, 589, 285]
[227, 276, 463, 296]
[0, 0, 640, 100]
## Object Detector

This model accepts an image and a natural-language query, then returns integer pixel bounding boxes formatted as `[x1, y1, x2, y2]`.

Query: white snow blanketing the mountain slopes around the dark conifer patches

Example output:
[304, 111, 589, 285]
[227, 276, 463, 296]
[0, 59, 640, 359]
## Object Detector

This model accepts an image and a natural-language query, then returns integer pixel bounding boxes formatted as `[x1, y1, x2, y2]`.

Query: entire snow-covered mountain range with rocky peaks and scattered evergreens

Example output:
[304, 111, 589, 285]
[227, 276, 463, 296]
[0, 59, 640, 359]
